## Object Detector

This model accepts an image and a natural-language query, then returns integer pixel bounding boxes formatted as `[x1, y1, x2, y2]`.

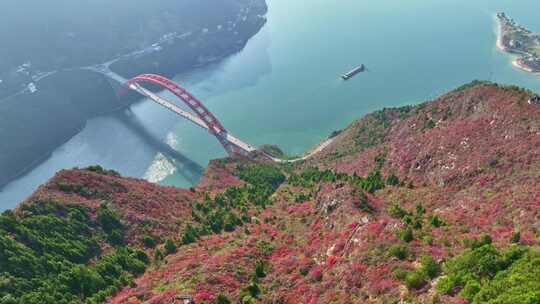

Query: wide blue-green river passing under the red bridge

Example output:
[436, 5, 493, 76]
[0, 0, 540, 210]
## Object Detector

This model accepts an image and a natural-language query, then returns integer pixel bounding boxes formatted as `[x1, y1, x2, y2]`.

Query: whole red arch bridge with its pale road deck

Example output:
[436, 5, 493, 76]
[125, 74, 272, 162]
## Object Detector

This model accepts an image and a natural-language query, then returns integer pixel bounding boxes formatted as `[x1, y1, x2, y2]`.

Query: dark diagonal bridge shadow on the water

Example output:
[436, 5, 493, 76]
[116, 110, 204, 185]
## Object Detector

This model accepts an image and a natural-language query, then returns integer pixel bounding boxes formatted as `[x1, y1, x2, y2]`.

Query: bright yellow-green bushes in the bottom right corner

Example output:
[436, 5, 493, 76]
[437, 239, 540, 304]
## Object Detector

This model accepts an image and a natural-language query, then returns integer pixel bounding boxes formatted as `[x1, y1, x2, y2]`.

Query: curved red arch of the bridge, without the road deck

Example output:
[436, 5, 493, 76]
[125, 74, 251, 156]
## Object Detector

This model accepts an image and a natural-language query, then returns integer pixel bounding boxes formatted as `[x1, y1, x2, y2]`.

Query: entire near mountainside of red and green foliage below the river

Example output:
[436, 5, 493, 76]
[0, 82, 540, 304]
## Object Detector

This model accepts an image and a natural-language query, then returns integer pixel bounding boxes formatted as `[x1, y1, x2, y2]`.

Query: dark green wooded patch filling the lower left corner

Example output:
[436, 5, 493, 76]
[0, 201, 148, 304]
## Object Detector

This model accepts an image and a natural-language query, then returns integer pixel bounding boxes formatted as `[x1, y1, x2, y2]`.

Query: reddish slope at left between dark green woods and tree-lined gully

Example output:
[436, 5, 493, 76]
[27, 168, 195, 244]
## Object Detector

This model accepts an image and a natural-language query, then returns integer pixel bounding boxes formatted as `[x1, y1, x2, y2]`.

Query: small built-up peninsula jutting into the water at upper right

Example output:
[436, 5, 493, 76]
[497, 13, 540, 73]
